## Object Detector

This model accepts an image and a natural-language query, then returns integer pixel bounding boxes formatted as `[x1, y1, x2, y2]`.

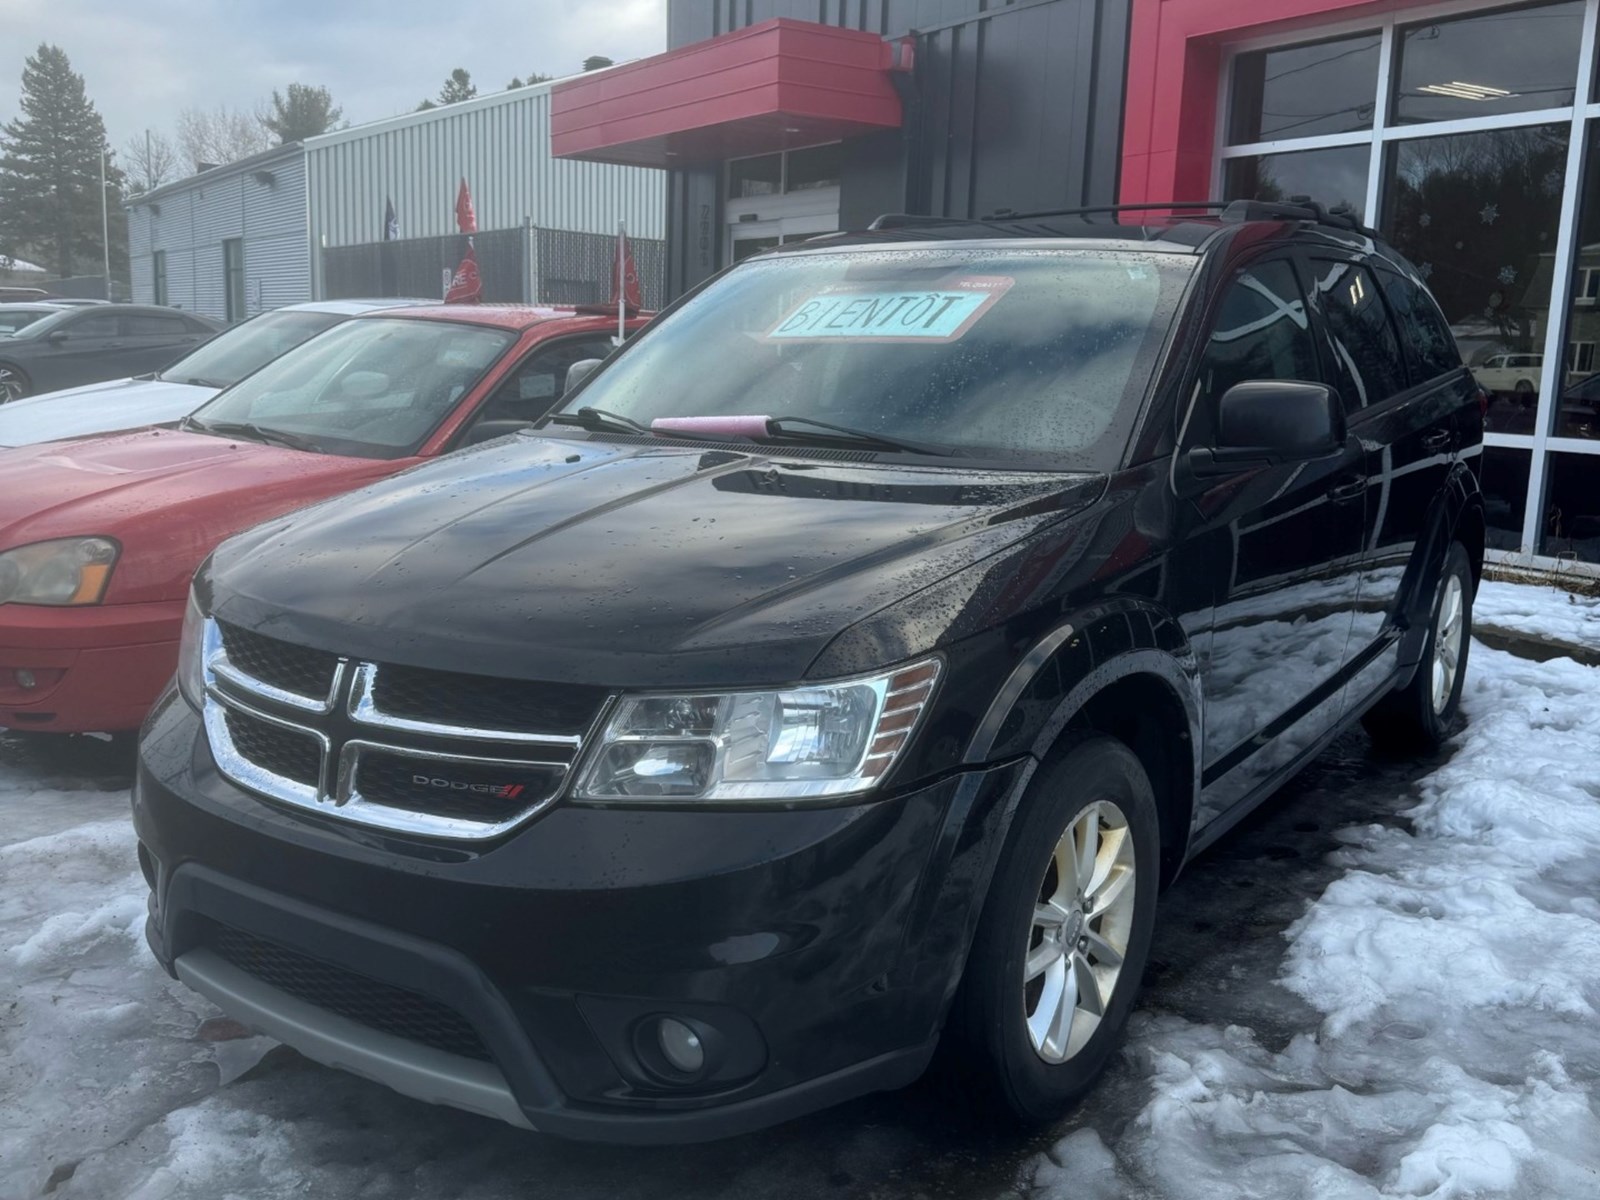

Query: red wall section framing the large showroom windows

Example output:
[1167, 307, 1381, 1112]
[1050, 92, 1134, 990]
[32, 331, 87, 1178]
[1120, 0, 1452, 205]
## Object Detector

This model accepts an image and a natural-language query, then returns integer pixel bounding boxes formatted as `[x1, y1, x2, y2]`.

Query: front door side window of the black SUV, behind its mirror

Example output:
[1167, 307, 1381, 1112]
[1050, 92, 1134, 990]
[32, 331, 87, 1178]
[1192, 261, 1322, 437]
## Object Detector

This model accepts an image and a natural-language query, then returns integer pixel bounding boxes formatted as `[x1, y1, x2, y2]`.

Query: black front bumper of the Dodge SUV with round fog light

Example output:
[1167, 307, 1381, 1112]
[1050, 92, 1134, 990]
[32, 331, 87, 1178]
[134, 694, 1024, 1142]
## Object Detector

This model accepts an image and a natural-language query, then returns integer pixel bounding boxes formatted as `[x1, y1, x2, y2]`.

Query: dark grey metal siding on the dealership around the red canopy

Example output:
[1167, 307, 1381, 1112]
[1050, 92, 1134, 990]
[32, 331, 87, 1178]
[667, 0, 1131, 294]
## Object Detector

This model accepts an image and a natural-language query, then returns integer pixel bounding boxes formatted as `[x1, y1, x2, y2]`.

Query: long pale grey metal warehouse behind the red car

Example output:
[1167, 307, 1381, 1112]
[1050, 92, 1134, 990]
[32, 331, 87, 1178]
[126, 83, 666, 322]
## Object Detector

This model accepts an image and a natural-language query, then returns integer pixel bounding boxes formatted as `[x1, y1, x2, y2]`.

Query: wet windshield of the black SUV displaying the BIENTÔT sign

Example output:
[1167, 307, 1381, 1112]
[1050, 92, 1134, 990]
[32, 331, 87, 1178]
[566, 248, 1190, 470]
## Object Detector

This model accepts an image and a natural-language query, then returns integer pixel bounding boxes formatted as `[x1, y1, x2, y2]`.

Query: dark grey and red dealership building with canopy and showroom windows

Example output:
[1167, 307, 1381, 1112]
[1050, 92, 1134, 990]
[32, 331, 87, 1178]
[550, 0, 1600, 573]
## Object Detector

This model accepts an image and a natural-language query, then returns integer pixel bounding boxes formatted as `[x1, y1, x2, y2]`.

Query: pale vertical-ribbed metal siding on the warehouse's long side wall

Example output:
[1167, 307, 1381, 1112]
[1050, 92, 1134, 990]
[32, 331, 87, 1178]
[306, 85, 666, 246]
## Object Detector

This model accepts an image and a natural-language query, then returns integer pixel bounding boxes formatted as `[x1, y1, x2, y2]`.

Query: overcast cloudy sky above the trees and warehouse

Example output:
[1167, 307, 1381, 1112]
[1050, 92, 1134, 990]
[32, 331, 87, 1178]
[0, 0, 667, 150]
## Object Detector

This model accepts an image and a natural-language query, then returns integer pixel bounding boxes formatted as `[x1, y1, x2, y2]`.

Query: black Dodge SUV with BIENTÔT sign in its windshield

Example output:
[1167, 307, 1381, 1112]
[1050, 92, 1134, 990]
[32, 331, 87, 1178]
[133, 203, 1483, 1142]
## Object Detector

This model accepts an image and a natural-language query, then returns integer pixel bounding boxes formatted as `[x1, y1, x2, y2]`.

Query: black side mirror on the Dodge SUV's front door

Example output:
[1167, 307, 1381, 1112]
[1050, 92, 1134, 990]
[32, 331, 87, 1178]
[1189, 379, 1346, 477]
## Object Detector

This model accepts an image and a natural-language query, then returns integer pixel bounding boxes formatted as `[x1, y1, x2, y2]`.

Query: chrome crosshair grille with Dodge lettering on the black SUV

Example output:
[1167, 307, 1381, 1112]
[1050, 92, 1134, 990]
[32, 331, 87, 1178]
[202, 621, 610, 840]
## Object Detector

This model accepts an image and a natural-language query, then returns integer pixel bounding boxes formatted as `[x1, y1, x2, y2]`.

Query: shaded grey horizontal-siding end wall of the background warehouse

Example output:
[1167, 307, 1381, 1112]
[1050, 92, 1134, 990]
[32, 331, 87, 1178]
[128, 147, 312, 318]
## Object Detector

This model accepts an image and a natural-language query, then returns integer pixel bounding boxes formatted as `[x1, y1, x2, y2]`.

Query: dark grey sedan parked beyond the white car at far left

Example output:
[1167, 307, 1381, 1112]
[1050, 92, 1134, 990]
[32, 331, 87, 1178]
[0, 304, 222, 403]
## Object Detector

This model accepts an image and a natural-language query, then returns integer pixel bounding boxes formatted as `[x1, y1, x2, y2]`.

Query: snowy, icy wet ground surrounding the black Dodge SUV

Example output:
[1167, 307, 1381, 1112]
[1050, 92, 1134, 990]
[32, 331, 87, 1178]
[0, 620, 1600, 1200]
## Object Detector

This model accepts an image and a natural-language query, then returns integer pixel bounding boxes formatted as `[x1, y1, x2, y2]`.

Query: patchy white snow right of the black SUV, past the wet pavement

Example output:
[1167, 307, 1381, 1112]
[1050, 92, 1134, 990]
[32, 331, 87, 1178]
[1032, 645, 1600, 1200]
